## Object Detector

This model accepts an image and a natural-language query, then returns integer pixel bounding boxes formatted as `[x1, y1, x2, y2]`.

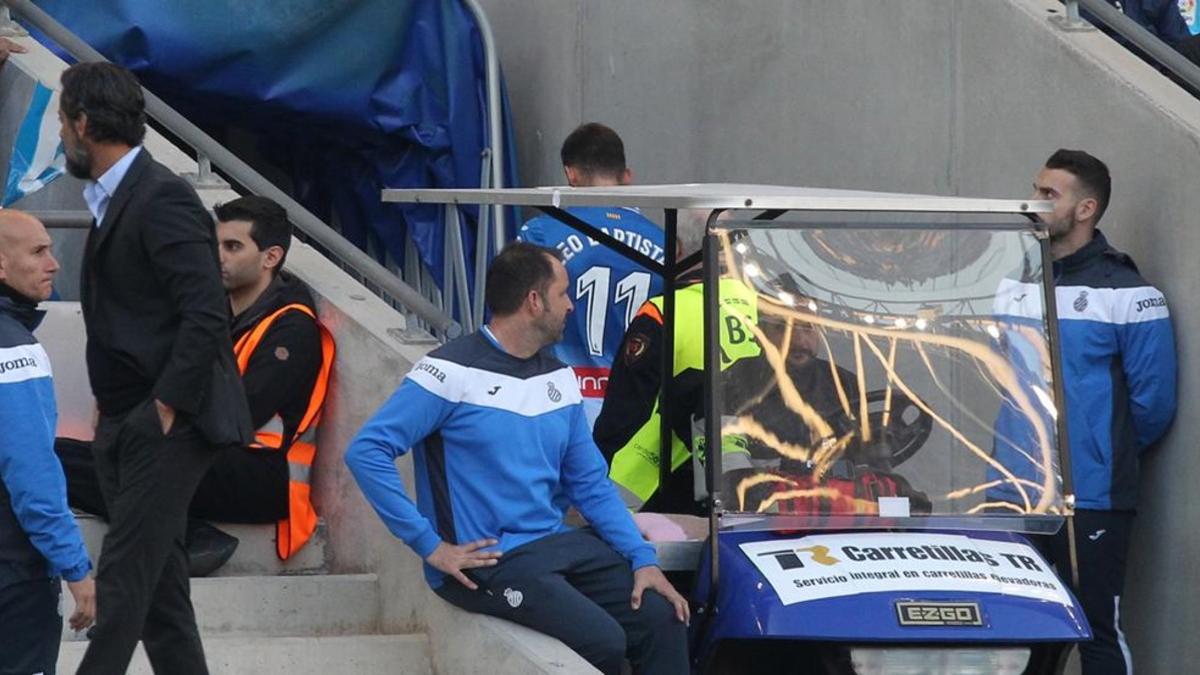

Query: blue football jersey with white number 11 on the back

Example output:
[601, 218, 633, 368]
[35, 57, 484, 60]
[517, 207, 664, 423]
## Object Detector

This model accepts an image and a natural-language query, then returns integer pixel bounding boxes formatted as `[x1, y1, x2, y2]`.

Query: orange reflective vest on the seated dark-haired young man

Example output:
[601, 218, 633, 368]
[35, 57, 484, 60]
[233, 304, 334, 560]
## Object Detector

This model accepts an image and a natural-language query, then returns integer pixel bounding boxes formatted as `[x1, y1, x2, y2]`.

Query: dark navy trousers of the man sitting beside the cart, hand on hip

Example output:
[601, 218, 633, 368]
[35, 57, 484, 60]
[436, 530, 688, 675]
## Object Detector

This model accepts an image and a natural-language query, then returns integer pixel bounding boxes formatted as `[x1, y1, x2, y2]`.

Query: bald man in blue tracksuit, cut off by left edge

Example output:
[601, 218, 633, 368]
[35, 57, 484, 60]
[0, 209, 96, 674]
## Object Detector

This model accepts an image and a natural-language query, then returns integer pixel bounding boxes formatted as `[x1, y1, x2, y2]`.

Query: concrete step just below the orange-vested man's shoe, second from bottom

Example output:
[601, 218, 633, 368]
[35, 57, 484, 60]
[62, 574, 380, 641]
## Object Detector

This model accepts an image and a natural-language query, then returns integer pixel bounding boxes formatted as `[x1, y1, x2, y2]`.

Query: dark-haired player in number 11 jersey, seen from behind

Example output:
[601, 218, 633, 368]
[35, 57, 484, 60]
[517, 123, 664, 424]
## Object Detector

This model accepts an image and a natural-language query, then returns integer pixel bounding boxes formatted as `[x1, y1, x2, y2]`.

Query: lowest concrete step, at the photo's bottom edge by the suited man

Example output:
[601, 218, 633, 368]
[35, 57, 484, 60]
[59, 634, 433, 675]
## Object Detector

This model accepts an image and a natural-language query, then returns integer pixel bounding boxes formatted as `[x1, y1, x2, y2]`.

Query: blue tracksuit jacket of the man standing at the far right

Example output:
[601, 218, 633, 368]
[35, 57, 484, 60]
[989, 231, 1176, 510]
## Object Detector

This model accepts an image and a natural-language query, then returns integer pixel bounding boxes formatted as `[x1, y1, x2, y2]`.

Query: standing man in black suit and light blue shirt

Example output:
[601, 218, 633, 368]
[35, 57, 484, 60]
[59, 62, 253, 674]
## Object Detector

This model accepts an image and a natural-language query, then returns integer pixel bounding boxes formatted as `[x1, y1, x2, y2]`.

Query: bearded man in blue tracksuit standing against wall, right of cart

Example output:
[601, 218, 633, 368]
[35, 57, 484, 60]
[1027, 150, 1176, 675]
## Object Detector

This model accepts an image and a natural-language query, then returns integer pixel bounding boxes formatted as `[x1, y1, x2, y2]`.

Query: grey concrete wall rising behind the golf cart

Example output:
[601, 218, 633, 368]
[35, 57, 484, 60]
[481, 0, 1200, 673]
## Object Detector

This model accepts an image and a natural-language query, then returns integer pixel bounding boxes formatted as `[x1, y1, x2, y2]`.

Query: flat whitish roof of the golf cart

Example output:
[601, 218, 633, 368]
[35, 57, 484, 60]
[383, 183, 1052, 214]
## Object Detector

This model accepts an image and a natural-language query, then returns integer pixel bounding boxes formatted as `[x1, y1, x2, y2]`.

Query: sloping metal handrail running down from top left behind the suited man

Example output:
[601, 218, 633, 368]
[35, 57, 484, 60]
[0, 0, 462, 338]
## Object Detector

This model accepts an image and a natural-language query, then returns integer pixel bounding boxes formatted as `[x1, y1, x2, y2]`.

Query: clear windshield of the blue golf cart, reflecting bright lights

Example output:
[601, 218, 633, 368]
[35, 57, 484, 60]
[695, 221, 1064, 532]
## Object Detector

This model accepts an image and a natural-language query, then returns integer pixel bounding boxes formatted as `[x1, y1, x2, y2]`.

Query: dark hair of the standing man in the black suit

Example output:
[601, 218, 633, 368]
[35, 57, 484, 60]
[59, 62, 146, 147]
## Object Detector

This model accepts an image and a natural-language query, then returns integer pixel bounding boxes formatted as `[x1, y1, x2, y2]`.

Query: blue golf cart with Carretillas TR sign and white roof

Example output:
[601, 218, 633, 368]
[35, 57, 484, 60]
[384, 185, 1091, 674]
